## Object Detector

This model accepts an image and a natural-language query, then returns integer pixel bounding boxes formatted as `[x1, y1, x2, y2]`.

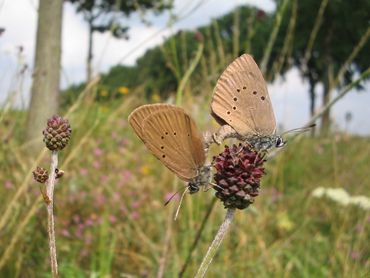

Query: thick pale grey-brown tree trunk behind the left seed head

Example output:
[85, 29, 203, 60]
[26, 0, 63, 152]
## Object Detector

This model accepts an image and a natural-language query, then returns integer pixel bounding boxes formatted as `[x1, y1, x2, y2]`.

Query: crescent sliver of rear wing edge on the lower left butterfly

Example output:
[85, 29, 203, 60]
[128, 103, 174, 142]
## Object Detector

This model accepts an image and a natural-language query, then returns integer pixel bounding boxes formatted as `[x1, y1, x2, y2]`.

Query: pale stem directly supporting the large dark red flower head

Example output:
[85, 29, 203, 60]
[195, 209, 235, 278]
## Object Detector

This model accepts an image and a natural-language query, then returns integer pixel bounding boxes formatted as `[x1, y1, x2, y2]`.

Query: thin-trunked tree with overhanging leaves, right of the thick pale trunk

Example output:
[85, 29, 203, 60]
[69, 0, 172, 82]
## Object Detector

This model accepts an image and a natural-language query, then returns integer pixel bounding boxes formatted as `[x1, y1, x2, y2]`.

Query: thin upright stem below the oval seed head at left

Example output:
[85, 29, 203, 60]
[46, 151, 58, 278]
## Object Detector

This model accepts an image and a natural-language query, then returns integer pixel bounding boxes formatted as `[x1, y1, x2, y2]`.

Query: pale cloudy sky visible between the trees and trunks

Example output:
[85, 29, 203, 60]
[0, 0, 370, 135]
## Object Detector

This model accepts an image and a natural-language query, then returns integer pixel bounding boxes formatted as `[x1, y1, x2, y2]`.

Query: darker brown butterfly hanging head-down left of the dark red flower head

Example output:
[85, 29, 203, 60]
[129, 104, 210, 193]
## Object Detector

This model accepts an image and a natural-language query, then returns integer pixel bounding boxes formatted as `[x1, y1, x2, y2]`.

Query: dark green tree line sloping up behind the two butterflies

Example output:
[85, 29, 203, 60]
[62, 6, 278, 104]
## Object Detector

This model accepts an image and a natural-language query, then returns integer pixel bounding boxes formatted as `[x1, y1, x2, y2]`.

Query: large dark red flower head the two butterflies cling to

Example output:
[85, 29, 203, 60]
[213, 144, 265, 209]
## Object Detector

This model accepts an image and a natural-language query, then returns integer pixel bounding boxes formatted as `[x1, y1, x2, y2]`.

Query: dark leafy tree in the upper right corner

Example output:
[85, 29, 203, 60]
[280, 0, 370, 134]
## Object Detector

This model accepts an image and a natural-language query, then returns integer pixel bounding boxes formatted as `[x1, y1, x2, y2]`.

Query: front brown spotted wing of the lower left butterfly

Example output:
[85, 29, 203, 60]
[142, 107, 205, 181]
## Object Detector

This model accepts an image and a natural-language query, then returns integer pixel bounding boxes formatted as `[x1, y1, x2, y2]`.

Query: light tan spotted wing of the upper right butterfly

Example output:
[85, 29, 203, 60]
[211, 54, 276, 135]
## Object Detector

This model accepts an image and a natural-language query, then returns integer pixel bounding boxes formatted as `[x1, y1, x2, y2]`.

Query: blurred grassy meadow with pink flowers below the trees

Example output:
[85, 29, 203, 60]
[0, 98, 370, 277]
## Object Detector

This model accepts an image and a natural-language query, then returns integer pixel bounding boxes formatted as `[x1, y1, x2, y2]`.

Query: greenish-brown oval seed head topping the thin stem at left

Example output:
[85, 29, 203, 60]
[42, 115, 72, 151]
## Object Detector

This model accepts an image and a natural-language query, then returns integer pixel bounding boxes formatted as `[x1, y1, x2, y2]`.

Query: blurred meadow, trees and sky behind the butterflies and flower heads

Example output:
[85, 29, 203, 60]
[0, 0, 370, 277]
